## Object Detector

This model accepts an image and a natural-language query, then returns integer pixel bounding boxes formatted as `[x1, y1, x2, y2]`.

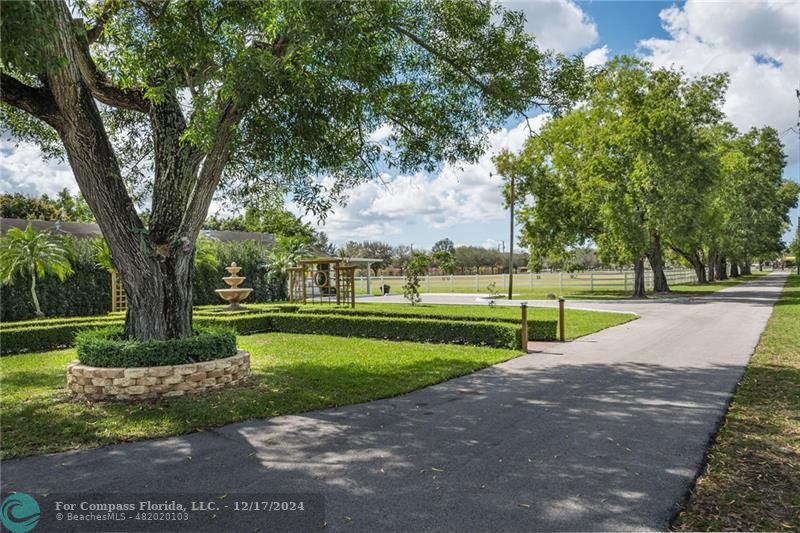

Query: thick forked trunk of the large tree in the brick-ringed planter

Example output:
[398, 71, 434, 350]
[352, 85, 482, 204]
[28, 2, 241, 340]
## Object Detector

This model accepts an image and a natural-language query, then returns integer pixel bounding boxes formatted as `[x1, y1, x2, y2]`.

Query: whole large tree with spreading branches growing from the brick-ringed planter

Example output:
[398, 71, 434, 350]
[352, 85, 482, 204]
[0, 0, 583, 339]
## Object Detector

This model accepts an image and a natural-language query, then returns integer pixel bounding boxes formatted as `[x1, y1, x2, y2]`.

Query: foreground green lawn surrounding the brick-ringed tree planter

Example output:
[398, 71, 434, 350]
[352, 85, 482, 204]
[0, 333, 519, 459]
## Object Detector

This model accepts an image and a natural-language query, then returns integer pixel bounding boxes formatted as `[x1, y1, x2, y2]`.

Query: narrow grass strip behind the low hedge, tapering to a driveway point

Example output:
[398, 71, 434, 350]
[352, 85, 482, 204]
[346, 303, 636, 339]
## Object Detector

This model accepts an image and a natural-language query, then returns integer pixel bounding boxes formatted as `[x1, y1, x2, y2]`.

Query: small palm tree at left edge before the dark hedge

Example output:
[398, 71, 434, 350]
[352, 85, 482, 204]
[0, 222, 72, 317]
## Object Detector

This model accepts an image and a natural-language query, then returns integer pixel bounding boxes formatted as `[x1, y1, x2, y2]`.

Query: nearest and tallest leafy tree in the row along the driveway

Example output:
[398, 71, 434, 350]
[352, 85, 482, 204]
[497, 57, 726, 297]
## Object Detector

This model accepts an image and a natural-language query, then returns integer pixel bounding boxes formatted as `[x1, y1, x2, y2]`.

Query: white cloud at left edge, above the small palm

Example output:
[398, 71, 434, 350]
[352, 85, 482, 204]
[0, 140, 78, 196]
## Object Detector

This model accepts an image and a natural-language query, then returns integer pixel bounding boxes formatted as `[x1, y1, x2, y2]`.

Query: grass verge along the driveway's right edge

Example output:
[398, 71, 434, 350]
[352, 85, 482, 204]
[673, 274, 800, 531]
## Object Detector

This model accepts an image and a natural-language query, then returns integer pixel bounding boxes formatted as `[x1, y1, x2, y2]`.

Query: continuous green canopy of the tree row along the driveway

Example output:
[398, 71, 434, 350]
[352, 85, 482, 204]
[497, 57, 797, 296]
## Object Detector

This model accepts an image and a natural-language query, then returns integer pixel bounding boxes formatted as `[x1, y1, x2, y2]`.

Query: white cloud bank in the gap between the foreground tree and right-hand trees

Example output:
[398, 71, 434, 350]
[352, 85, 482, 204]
[300, 115, 548, 242]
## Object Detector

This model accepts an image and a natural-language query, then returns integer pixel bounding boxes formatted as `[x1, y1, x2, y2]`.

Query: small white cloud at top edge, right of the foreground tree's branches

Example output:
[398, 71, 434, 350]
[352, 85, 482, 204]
[502, 0, 598, 53]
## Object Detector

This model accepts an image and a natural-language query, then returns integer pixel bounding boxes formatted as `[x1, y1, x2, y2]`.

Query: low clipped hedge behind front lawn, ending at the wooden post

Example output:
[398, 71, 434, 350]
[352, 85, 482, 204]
[269, 313, 522, 349]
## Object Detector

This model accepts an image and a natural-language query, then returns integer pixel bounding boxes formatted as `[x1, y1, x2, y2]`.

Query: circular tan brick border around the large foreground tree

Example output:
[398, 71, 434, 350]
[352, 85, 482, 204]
[67, 350, 250, 402]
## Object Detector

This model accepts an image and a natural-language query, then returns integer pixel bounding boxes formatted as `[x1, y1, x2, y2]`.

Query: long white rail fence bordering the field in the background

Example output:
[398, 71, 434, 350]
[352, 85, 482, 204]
[355, 269, 697, 295]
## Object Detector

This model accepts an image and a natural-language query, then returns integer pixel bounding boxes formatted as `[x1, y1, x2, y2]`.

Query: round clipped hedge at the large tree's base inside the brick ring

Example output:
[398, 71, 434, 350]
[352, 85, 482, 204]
[75, 327, 236, 368]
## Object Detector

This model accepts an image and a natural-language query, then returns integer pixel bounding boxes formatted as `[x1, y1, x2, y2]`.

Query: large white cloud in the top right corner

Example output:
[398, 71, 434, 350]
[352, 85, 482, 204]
[639, 0, 800, 163]
